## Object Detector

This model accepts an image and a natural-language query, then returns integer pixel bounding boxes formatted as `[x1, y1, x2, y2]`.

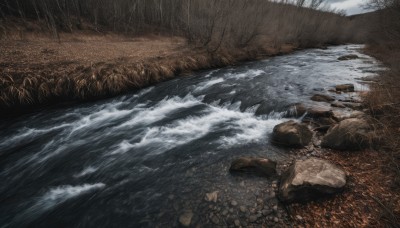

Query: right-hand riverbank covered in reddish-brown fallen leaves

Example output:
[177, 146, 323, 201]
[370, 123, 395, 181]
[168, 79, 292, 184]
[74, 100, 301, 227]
[288, 46, 400, 227]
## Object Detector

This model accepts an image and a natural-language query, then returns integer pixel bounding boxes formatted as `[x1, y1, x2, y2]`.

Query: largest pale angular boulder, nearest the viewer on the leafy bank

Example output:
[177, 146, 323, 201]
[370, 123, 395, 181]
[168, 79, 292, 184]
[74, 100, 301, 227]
[279, 158, 346, 203]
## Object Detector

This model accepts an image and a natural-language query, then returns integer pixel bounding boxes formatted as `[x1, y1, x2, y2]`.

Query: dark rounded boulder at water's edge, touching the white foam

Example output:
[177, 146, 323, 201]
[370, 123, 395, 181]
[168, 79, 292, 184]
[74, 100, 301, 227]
[272, 120, 313, 147]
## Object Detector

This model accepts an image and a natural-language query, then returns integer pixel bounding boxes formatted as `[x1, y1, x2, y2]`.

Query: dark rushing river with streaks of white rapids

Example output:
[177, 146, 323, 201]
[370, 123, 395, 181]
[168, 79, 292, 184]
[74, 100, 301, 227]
[0, 45, 382, 227]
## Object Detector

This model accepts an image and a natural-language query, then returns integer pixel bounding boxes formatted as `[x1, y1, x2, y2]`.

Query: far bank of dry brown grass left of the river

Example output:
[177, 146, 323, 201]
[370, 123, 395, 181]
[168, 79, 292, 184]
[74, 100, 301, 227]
[0, 34, 296, 116]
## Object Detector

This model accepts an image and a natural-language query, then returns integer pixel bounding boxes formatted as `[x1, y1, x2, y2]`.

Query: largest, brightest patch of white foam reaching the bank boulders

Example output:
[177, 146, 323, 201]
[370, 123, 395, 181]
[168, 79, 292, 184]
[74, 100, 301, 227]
[132, 102, 283, 155]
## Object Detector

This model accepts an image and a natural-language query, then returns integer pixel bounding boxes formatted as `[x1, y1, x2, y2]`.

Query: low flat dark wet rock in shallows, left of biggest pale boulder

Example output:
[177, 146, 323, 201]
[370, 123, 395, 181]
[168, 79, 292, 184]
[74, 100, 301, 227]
[229, 157, 276, 176]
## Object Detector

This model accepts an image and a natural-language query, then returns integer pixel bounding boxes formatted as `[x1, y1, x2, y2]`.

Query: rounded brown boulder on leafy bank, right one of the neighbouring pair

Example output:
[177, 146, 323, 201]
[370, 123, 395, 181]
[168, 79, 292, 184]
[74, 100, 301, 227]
[321, 118, 374, 150]
